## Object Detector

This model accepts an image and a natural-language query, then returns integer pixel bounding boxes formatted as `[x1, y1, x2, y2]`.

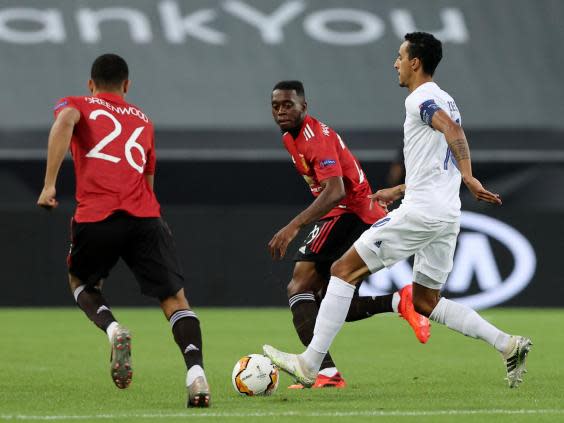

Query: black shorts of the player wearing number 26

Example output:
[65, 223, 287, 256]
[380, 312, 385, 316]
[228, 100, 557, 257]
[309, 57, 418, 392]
[67, 212, 184, 300]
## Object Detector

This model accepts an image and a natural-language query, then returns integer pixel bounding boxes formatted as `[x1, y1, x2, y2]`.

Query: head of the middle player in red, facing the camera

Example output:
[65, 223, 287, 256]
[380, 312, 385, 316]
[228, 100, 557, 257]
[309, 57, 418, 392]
[271, 81, 307, 131]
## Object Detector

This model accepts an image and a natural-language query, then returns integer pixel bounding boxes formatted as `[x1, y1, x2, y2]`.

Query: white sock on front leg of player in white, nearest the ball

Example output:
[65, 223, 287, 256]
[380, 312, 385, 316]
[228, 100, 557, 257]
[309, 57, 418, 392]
[300, 276, 355, 372]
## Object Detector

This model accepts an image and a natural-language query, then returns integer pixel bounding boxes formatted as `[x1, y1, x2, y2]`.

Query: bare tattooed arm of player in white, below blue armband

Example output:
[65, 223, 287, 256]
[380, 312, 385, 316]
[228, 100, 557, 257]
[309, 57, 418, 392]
[431, 109, 501, 205]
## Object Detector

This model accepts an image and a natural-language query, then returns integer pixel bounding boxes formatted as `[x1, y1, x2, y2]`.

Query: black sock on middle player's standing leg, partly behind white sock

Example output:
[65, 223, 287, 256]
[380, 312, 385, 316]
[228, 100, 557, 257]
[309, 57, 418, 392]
[288, 292, 337, 370]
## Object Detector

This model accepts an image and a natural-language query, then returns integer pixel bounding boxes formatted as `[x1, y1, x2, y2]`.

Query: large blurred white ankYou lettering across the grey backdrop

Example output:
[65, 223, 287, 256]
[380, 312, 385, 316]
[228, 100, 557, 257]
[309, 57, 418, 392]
[0, 0, 470, 46]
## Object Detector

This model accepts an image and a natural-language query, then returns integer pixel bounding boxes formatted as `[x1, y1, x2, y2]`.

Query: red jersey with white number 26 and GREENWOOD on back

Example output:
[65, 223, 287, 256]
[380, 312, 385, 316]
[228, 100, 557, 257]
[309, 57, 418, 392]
[54, 93, 160, 222]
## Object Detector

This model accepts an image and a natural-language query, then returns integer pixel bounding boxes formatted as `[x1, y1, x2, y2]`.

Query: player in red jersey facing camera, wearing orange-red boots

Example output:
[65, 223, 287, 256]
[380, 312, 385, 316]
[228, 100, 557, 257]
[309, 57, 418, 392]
[268, 81, 430, 388]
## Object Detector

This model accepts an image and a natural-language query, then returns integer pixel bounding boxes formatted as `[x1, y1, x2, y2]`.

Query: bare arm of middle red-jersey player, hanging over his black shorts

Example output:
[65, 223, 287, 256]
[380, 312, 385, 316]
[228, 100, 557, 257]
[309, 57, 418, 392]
[268, 176, 346, 259]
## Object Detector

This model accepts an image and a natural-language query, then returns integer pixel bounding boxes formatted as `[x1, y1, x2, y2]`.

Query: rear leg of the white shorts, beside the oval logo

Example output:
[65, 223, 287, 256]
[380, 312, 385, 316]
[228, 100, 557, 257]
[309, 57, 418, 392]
[413, 222, 460, 290]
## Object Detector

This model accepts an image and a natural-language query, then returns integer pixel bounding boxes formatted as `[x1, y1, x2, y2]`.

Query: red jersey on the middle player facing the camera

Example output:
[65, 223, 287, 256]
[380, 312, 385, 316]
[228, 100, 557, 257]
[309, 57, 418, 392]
[282, 115, 386, 224]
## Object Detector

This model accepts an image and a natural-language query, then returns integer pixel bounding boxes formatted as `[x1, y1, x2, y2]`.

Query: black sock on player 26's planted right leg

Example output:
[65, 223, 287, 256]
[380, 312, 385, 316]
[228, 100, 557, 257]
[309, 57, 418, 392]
[169, 310, 204, 369]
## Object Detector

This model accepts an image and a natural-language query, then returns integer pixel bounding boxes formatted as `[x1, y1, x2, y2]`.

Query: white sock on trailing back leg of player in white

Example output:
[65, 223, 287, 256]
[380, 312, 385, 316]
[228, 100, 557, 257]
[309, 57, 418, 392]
[429, 298, 511, 353]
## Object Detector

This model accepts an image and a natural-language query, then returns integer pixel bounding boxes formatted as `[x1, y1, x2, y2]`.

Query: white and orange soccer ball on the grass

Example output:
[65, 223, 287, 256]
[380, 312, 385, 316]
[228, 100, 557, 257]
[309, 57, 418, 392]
[231, 354, 278, 396]
